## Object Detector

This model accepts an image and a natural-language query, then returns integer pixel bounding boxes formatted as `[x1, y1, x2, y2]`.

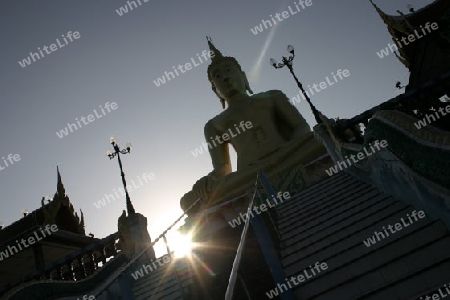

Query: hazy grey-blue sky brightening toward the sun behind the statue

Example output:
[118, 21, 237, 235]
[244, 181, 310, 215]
[0, 0, 432, 254]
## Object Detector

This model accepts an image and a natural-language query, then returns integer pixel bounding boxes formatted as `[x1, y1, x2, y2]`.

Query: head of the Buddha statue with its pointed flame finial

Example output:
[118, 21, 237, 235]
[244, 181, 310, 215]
[208, 38, 253, 108]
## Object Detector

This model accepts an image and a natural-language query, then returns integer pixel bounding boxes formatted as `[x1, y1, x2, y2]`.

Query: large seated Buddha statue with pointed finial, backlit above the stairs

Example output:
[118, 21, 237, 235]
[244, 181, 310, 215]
[181, 39, 325, 210]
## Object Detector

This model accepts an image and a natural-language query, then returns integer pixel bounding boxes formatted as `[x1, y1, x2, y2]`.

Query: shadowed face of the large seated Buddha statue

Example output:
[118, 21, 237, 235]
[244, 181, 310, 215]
[210, 60, 247, 99]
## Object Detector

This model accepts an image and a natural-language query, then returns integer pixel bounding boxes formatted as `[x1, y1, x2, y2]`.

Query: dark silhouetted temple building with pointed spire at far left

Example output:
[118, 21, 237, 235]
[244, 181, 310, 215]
[0, 170, 115, 292]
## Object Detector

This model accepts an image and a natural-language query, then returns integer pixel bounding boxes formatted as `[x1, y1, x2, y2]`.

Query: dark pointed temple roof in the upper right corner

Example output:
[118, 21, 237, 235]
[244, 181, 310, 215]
[369, 0, 450, 69]
